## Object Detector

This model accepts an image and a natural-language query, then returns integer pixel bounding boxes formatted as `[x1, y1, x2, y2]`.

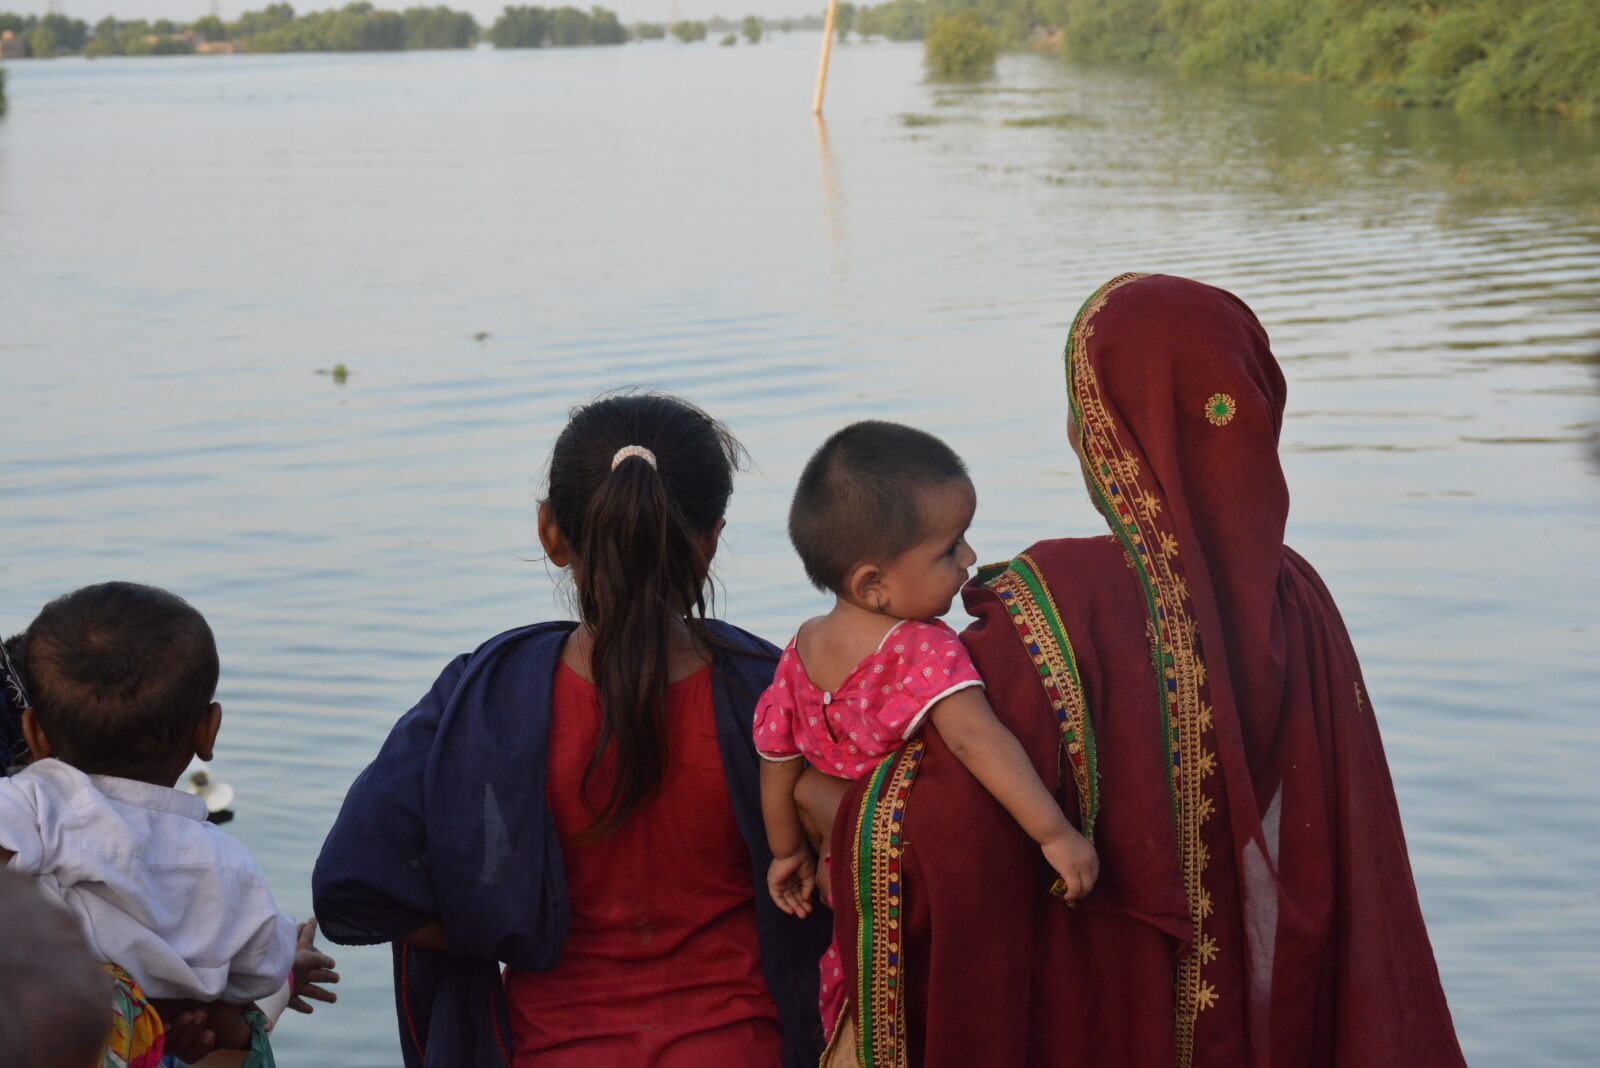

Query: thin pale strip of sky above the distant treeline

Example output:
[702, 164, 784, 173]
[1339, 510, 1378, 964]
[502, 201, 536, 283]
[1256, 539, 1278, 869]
[0, 0, 826, 26]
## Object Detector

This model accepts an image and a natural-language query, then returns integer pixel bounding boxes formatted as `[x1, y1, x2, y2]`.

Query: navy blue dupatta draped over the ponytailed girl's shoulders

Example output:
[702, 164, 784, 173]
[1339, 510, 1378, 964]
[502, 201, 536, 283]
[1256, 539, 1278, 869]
[312, 620, 832, 1068]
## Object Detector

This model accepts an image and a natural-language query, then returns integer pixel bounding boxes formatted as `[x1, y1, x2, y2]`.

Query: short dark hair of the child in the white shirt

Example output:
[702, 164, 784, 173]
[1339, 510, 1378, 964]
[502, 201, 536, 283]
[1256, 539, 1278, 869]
[24, 582, 218, 777]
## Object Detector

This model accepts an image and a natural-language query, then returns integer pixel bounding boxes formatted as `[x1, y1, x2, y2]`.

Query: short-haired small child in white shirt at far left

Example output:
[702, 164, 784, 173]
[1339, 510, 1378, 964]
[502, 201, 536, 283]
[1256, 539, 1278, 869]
[0, 582, 336, 1010]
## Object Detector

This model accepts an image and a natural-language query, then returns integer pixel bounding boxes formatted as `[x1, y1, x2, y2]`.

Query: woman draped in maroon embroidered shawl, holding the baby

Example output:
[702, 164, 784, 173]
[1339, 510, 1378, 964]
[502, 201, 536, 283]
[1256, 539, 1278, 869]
[834, 275, 1462, 1068]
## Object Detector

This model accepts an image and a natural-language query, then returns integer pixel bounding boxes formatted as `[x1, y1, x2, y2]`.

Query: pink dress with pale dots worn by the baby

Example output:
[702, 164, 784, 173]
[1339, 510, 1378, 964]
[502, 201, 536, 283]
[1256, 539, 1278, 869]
[755, 619, 984, 1034]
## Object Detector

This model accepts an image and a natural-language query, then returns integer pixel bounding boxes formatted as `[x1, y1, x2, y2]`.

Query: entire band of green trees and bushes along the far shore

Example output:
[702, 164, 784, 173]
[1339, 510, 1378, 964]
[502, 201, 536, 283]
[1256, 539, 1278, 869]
[9, 0, 1600, 117]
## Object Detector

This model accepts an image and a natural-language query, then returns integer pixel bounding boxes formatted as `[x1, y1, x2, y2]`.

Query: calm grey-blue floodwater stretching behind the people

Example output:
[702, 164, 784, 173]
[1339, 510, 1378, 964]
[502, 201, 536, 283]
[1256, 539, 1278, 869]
[0, 35, 1600, 1065]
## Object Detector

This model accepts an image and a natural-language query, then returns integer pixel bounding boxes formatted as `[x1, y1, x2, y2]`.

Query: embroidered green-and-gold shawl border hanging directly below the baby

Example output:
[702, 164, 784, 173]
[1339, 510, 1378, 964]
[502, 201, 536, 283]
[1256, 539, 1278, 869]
[835, 739, 925, 1068]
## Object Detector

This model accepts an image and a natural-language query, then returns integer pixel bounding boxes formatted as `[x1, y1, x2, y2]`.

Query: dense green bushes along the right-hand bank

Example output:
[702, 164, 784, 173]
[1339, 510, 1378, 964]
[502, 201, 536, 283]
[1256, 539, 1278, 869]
[851, 0, 1600, 117]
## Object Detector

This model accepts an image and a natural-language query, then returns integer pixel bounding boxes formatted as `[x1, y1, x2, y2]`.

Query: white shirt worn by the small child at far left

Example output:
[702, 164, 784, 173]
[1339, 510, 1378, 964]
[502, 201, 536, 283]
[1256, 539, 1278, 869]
[0, 759, 294, 1002]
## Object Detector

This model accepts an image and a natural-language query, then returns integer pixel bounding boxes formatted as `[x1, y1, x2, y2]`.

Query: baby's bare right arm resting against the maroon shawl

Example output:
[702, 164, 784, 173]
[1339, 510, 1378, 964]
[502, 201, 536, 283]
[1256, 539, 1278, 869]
[931, 687, 1099, 900]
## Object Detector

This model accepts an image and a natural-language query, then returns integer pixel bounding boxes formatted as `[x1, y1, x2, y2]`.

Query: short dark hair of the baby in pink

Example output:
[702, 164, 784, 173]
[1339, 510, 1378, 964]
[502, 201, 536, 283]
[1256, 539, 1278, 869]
[789, 419, 966, 593]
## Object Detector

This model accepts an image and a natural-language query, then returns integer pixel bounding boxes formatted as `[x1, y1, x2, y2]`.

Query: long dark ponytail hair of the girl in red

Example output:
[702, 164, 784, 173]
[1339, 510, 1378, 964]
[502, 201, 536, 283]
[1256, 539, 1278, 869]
[549, 393, 744, 836]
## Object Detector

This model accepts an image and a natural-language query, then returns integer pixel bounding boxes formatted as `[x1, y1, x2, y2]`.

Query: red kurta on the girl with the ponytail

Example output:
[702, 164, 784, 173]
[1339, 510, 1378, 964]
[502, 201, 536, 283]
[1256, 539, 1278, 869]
[506, 665, 782, 1068]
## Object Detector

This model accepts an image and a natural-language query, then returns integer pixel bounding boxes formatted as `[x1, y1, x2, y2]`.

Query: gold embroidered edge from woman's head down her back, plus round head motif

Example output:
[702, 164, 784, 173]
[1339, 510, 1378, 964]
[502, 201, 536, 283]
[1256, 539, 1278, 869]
[1066, 275, 1237, 1068]
